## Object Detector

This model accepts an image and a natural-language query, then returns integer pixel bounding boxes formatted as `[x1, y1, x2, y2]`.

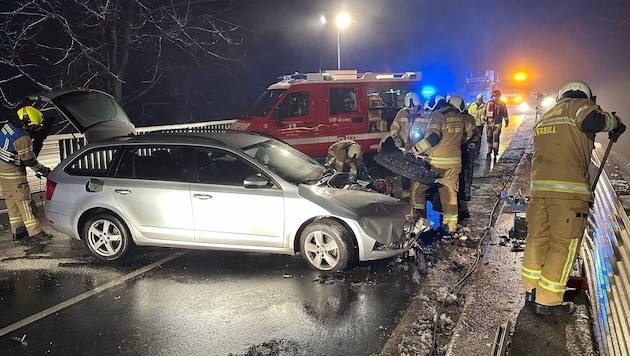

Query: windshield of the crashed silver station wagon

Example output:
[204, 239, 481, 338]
[243, 140, 324, 184]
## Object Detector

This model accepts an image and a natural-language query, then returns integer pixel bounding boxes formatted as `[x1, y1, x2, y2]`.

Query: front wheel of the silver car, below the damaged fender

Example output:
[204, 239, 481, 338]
[300, 220, 357, 272]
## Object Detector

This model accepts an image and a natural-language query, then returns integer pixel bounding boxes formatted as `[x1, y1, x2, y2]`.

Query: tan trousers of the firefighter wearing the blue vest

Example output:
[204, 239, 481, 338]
[0, 176, 42, 236]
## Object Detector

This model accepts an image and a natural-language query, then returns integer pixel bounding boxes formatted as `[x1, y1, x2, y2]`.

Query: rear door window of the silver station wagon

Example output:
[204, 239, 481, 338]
[115, 146, 183, 182]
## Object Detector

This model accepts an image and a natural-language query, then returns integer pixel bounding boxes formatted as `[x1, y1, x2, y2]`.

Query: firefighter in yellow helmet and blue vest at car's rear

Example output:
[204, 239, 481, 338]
[0, 106, 52, 245]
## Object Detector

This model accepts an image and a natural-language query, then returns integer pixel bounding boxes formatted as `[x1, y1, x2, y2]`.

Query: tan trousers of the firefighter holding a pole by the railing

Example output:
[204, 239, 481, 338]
[521, 198, 590, 305]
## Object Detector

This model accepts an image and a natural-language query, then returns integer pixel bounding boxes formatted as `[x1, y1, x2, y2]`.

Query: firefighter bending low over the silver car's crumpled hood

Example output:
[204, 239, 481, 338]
[325, 140, 367, 180]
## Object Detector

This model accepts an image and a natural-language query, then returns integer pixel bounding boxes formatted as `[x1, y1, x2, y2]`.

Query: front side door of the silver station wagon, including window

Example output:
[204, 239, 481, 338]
[190, 147, 285, 250]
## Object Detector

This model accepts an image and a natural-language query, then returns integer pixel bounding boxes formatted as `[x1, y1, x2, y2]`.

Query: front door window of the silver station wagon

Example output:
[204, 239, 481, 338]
[193, 147, 262, 186]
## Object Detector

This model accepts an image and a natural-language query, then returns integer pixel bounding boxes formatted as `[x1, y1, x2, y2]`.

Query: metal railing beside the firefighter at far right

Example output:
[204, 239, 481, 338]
[580, 155, 630, 356]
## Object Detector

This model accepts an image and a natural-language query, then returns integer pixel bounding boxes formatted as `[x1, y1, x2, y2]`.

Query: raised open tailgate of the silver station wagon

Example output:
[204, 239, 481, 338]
[27, 89, 136, 143]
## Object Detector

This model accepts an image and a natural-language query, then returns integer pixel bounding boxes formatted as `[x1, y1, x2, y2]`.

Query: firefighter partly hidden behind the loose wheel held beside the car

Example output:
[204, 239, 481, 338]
[389, 92, 429, 199]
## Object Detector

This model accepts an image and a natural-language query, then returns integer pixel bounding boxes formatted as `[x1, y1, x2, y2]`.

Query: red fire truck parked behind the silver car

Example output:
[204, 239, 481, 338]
[230, 70, 422, 158]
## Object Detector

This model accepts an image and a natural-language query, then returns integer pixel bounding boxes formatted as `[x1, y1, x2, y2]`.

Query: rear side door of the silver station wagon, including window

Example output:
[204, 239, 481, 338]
[107, 145, 194, 241]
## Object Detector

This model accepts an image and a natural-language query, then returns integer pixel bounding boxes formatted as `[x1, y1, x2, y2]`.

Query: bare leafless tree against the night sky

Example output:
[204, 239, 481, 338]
[0, 0, 241, 121]
